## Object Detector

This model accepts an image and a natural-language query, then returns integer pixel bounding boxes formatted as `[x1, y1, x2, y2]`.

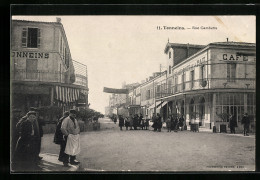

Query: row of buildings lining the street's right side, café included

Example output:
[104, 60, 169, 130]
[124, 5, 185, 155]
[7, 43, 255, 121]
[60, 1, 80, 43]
[106, 42, 256, 131]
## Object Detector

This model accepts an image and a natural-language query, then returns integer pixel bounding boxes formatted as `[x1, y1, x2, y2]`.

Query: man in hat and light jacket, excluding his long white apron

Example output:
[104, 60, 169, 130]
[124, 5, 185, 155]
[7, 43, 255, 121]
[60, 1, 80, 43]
[61, 109, 80, 167]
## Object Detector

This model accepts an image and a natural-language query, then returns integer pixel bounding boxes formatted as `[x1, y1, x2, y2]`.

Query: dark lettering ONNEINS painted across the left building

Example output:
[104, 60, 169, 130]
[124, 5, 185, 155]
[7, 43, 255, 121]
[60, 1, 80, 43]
[11, 51, 50, 59]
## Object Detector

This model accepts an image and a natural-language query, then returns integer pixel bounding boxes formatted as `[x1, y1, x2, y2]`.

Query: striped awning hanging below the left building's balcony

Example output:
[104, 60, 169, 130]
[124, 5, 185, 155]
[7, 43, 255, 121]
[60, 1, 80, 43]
[54, 86, 79, 103]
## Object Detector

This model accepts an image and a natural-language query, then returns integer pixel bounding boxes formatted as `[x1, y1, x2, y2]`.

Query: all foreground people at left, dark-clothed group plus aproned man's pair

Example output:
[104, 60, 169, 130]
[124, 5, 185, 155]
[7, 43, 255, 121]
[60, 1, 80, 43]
[11, 107, 80, 171]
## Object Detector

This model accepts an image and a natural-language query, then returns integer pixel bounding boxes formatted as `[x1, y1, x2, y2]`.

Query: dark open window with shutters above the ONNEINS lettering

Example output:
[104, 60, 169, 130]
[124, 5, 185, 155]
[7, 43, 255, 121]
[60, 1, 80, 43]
[22, 28, 41, 48]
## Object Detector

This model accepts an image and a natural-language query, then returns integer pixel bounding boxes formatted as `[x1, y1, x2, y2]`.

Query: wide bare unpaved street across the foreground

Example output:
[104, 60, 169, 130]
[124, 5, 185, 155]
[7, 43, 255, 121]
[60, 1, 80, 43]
[42, 119, 255, 171]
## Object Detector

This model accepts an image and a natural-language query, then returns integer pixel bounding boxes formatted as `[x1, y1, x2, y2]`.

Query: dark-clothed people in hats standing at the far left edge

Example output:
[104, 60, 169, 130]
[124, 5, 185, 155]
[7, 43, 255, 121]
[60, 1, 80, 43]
[11, 107, 45, 171]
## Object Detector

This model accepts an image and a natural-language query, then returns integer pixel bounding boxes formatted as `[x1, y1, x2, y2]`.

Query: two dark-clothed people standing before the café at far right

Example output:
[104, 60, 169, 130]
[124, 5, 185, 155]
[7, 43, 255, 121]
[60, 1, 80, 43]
[228, 113, 250, 136]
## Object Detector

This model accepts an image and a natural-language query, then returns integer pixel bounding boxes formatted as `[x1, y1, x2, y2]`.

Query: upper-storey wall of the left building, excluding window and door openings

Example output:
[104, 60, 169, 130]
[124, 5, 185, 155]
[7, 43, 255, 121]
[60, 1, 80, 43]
[11, 21, 73, 83]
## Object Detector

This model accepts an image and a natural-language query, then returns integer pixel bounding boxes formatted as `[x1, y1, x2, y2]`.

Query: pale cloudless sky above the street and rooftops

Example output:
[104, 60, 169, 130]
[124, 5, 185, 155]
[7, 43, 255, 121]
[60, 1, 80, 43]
[12, 15, 256, 113]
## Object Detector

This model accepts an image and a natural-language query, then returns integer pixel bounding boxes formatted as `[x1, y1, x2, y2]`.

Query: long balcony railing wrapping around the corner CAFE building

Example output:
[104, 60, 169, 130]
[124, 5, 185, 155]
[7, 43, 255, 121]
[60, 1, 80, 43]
[155, 78, 255, 98]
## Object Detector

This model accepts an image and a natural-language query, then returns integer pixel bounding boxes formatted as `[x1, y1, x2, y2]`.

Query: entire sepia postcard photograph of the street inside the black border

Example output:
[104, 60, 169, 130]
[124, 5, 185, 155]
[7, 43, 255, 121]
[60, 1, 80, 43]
[10, 15, 256, 174]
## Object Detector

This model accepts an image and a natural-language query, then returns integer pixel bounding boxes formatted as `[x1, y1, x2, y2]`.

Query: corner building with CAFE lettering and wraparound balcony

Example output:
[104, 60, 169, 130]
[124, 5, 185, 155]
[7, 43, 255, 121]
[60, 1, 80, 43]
[156, 42, 256, 131]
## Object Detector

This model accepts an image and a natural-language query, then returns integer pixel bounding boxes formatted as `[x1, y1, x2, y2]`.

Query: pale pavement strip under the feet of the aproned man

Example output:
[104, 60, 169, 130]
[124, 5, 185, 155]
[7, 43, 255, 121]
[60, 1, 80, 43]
[39, 153, 80, 172]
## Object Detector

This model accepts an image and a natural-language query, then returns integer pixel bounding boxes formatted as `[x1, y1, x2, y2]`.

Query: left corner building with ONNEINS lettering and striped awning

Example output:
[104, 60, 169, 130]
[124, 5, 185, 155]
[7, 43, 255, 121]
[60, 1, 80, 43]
[11, 18, 88, 116]
